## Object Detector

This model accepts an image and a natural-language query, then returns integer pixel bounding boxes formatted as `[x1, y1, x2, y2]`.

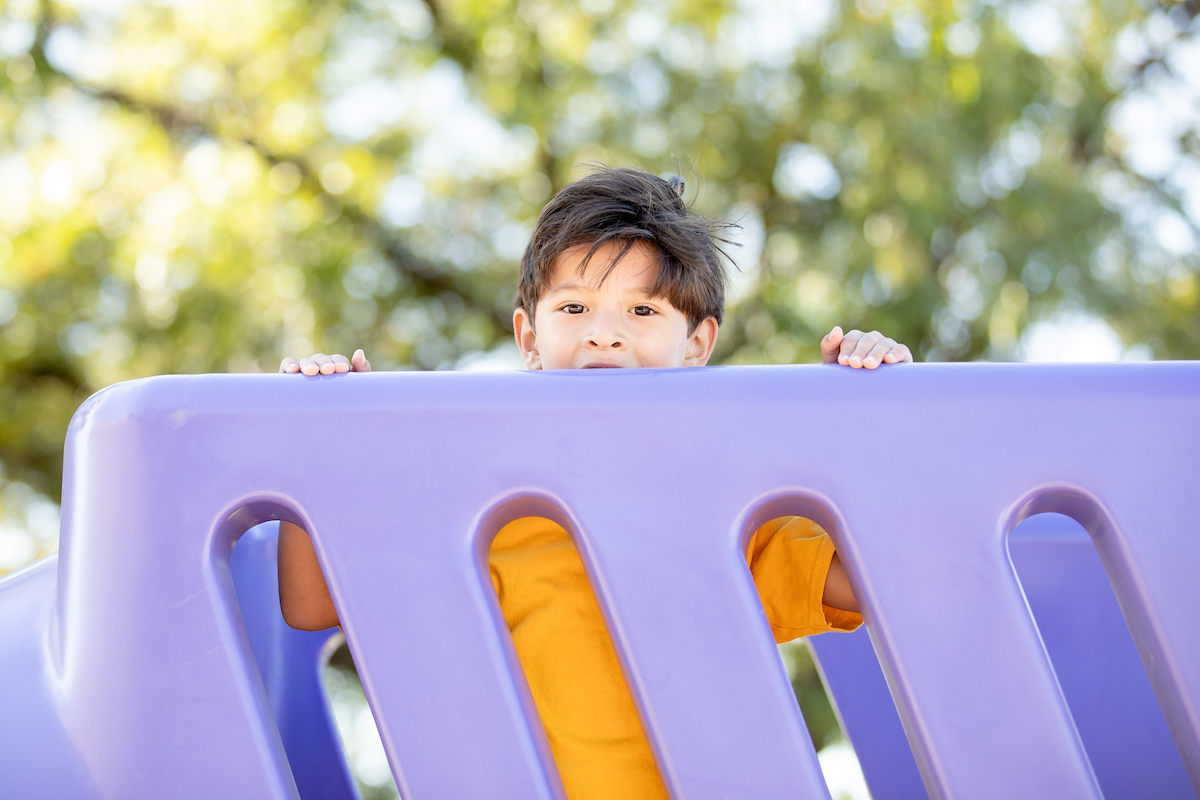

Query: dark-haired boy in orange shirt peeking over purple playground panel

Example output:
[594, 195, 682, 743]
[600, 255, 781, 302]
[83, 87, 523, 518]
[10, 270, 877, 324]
[280, 169, 912, 800]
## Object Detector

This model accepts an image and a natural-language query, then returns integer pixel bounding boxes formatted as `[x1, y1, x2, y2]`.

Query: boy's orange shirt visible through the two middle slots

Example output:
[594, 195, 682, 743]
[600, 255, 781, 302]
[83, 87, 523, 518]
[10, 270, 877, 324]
[488, 517, 863, 800]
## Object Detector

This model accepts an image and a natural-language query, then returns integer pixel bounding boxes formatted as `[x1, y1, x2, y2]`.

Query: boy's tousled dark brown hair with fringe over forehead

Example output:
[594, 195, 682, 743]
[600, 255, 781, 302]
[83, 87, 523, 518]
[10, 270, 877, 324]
[514, 167, 731, 331]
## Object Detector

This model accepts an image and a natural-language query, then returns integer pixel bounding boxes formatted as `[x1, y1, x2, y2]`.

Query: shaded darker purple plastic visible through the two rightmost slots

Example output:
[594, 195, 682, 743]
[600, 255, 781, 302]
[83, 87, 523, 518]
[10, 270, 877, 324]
[809, 513, 1196, 800]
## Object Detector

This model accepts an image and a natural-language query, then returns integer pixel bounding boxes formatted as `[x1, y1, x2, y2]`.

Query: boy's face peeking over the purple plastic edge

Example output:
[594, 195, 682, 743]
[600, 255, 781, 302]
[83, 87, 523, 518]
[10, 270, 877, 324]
[512, 242, 716, 369]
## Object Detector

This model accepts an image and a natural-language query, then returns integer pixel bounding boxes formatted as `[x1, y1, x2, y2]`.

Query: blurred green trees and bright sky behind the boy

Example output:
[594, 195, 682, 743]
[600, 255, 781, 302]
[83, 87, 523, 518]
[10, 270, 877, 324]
[0, 0, 1200, 796]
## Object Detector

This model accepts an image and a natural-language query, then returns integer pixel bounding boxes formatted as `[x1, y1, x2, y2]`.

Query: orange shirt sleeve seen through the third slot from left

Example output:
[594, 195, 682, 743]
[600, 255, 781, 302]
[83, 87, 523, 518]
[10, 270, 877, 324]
[746, 517, 863, 643]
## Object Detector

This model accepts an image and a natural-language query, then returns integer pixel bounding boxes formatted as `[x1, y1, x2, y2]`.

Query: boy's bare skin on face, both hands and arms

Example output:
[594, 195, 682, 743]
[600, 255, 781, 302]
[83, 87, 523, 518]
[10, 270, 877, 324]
[280, 243, 912, 631]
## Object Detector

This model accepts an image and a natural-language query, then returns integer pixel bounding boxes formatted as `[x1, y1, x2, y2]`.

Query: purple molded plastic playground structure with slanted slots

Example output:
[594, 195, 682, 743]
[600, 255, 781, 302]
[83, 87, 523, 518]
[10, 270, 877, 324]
[0, 363, 1200, 800]
